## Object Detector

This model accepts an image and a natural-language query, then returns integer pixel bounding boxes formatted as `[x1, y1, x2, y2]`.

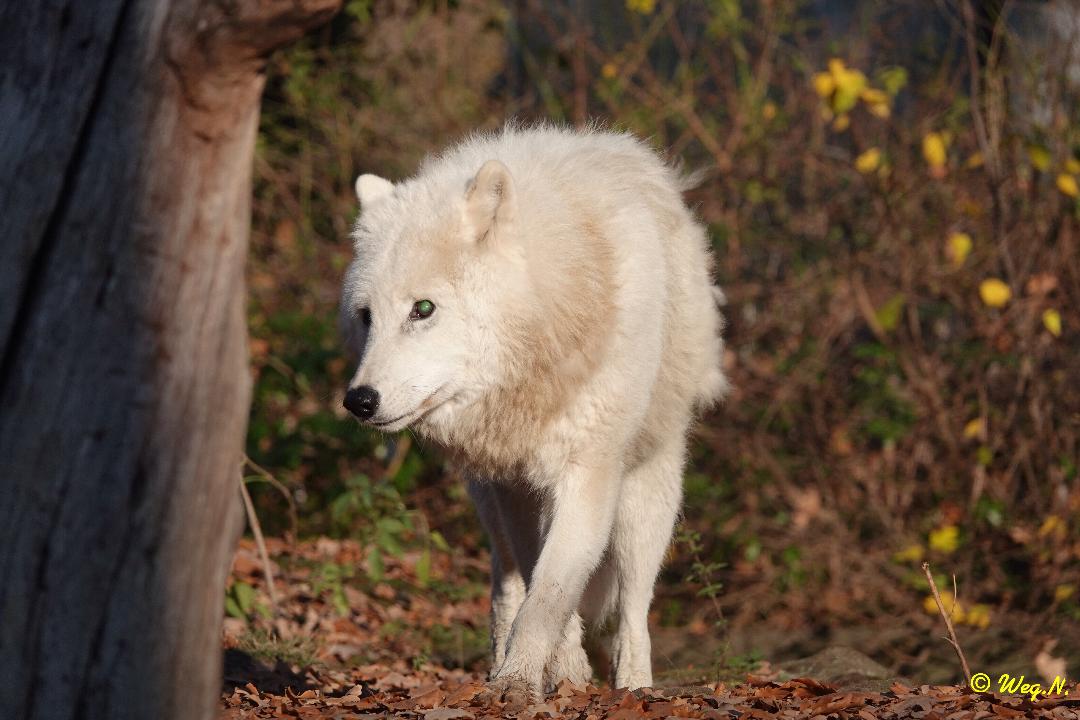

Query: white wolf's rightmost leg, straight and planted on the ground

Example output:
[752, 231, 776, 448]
[611, 436, 684, 690]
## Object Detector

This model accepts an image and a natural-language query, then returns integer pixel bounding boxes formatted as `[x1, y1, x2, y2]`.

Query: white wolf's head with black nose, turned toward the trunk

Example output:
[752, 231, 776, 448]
[341, 160, 524, 431]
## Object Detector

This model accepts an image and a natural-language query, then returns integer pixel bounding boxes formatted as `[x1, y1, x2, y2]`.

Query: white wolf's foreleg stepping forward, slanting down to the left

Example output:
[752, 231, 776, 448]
[491, 461, 619, 702]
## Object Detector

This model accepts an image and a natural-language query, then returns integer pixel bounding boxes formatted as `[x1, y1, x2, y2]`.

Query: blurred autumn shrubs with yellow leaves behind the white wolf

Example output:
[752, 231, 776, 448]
[247, 0, 1080, 677]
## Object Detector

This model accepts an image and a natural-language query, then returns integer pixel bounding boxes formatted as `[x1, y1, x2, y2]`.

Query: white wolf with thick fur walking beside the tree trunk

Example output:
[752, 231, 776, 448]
[342, 126, 725, 702]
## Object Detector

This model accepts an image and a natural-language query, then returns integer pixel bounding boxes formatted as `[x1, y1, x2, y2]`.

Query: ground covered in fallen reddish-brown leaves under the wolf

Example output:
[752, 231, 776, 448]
[219, 539, 1080, 720]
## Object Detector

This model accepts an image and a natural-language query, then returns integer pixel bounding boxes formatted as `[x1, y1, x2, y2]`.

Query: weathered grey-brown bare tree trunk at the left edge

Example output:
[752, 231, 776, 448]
[0, 0, 340, 719]
